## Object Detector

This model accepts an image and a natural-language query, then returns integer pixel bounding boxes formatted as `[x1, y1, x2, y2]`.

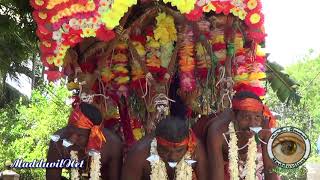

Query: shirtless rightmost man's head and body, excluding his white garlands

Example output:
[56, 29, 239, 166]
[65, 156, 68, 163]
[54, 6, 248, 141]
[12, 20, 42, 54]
[207, 92, 278, 180]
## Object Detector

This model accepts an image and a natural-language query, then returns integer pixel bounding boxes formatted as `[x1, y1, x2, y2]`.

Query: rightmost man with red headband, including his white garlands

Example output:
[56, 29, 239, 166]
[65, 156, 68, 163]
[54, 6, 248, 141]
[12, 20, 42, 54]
[207, 92, 278, 180]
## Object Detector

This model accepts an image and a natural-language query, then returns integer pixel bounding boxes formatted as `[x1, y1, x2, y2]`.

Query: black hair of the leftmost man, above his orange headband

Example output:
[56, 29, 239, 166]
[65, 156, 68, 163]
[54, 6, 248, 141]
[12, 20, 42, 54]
[80, 102, 102, 125]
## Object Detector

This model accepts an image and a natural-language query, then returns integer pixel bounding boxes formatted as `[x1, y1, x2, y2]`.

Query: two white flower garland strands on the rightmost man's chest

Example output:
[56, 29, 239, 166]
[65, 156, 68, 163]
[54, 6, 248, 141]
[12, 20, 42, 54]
[229, 122, 257, 180]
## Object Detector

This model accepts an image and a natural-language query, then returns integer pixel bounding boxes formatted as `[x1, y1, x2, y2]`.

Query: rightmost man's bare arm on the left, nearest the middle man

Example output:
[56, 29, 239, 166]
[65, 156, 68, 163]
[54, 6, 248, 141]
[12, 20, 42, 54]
[207, 125, 224, 180]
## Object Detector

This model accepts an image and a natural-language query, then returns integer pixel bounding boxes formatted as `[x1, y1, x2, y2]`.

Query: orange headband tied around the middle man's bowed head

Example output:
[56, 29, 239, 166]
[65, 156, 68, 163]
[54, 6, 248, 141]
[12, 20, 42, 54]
[156, 129, 197, 153]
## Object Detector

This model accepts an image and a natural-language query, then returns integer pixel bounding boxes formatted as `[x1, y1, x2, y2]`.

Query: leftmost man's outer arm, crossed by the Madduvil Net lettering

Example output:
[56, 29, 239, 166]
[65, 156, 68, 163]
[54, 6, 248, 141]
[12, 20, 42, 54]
[46, 141, 62, 180]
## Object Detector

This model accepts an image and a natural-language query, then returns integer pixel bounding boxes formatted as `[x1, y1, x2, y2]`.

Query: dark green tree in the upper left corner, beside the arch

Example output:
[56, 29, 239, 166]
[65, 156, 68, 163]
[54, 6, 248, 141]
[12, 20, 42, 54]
[0, 0, 42, 107]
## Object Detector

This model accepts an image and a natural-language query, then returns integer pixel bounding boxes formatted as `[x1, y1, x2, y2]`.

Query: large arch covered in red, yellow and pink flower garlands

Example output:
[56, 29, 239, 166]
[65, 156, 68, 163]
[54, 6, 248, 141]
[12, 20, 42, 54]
[30, 0, 266, 144]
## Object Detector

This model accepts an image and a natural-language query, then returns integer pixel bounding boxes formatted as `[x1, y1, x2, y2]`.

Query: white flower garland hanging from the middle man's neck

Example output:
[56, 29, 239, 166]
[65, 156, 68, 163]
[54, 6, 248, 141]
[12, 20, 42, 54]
[147, 139, 195, 180]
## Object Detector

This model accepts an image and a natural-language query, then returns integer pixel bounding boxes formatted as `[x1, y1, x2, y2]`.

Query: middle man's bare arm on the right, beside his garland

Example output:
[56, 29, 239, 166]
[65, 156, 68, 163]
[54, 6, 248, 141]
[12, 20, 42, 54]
[195, 141, 208, 180]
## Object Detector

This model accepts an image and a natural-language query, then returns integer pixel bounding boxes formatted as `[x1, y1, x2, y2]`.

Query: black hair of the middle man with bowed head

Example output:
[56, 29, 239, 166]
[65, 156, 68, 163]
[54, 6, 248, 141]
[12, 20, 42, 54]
[155, 116, 189, 143]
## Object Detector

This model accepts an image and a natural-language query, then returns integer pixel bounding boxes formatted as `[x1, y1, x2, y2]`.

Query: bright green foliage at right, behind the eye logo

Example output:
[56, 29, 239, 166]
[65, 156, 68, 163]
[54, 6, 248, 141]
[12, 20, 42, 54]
[266, 55, 320, 179]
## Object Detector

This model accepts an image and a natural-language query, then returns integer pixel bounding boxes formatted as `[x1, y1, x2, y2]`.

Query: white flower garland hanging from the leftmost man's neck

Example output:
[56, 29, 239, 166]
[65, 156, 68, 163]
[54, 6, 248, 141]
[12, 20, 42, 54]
[70, 151, 101, 180]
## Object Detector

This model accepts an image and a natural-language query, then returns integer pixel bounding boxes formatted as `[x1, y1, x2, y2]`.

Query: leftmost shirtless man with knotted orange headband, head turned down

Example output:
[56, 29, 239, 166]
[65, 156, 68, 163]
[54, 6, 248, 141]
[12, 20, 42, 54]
[46, 102, 122, 180]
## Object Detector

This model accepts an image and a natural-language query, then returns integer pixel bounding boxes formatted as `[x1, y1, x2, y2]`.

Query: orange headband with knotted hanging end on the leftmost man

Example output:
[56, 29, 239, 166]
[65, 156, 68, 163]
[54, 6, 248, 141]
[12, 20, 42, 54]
[68, 107, 106, 150]
